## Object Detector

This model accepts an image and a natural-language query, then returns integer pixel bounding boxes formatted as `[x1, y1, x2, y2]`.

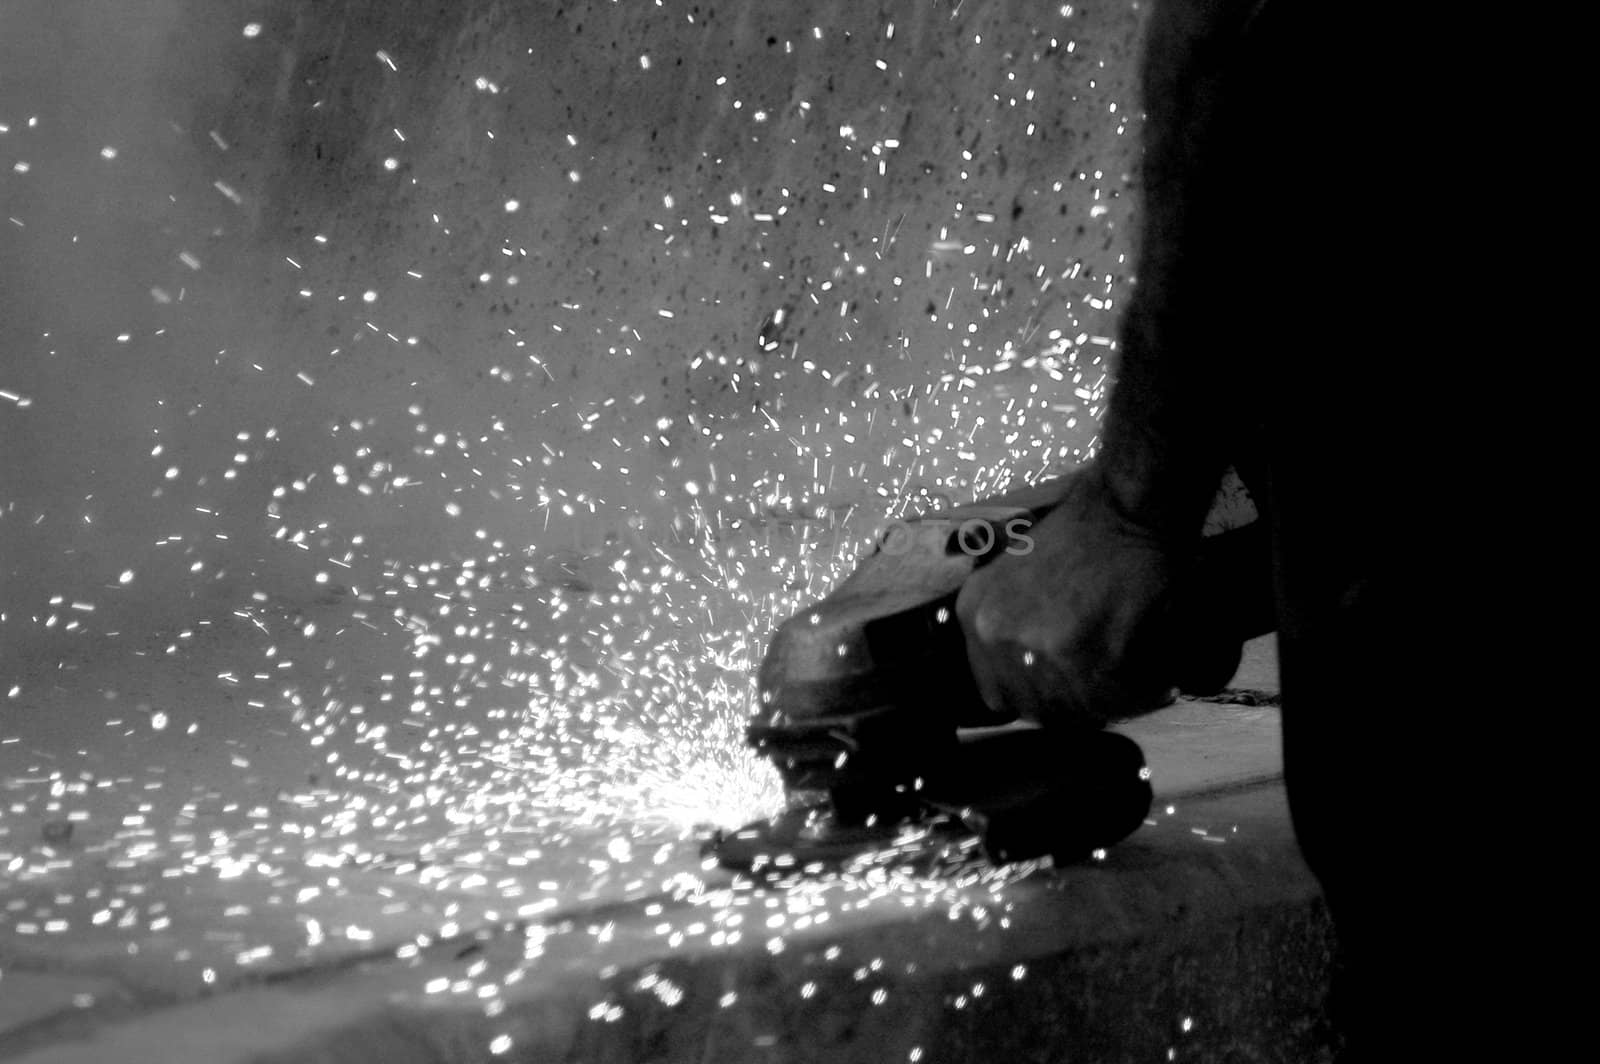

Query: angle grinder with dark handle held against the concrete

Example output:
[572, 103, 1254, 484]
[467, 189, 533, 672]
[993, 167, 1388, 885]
[707, 482, 1272, 870]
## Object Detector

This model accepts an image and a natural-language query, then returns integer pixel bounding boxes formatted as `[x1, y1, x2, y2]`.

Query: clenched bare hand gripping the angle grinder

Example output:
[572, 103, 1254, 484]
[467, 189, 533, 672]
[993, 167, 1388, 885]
[957, 466, 1198, 726]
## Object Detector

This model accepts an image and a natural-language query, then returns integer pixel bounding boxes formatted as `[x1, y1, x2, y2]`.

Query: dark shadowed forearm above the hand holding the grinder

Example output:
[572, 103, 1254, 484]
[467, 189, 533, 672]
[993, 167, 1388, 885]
[1096, 0, 1261, 539]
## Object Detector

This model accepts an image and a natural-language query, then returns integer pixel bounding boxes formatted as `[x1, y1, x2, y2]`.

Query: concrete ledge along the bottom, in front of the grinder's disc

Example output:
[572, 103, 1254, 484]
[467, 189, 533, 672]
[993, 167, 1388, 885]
[0, 771, 1333, 1064]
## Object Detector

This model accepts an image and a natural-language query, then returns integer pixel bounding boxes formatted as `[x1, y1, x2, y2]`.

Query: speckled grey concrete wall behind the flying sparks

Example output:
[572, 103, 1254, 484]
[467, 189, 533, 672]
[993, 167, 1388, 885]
[0, 0, 1141, 653]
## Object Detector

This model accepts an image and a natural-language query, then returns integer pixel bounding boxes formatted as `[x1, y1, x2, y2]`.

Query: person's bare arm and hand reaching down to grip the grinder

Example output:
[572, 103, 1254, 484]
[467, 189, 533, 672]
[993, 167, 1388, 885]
[957, 0, 1256, 726]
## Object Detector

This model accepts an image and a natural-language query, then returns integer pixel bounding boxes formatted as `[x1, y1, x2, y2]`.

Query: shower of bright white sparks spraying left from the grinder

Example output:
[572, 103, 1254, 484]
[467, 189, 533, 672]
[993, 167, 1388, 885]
[0, 0, 1132, 1030]
